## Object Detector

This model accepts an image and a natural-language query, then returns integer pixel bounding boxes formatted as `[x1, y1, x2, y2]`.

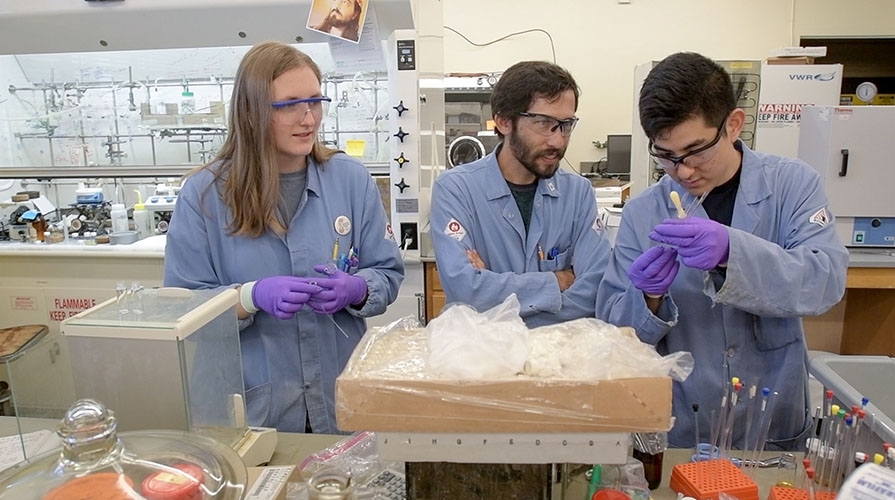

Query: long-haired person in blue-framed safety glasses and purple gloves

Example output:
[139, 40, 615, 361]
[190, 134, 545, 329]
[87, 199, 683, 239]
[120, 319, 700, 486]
[164, 42, 404, 434]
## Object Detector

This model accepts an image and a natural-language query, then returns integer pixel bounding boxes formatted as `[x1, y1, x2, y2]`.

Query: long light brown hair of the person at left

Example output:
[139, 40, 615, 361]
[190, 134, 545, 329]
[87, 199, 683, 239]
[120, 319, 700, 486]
[193, 42, 338, 238]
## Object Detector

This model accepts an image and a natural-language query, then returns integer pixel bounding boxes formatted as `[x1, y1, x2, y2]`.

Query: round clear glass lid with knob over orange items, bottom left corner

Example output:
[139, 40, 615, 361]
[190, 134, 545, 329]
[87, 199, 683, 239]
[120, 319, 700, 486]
[0, 399, 247, 500]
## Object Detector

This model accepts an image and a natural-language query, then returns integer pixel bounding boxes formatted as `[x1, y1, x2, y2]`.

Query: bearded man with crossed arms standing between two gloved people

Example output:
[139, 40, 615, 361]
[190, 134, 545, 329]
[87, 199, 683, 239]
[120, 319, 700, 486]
[430, 61, 610, 327]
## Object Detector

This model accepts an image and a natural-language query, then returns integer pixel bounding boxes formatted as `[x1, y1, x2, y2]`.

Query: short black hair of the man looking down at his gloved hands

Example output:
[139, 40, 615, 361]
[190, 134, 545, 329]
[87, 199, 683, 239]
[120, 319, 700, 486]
[639, 52, 736, 140]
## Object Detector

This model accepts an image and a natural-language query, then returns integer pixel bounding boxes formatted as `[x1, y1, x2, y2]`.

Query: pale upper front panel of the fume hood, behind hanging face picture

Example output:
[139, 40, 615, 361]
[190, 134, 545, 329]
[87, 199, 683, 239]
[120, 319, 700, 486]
[0, 0, 413, 54]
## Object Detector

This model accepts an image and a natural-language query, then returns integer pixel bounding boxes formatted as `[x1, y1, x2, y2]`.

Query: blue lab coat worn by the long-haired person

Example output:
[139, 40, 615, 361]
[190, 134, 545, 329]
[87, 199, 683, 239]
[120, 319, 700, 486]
[165, 154, 404, 433]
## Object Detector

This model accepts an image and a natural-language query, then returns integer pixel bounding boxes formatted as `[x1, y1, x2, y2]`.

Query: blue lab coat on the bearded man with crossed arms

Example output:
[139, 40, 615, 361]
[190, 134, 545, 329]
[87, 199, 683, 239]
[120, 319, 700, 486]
[430, 148, 611, 328]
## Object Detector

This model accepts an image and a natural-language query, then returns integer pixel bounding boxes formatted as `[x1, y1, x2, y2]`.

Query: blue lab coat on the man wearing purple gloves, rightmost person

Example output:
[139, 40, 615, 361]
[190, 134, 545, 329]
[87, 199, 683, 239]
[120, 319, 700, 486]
[597, 143, 848, 448]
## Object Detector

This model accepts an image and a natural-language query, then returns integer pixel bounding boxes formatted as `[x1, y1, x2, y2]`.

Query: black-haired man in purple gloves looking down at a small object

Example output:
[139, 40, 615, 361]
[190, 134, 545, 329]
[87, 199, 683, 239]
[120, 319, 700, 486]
[597, 53, 848, 449]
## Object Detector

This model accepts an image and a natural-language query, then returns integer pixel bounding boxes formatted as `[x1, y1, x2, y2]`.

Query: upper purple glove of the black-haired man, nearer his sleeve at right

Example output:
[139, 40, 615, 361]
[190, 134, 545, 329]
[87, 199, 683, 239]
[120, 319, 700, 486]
[649, 217, 730, 271]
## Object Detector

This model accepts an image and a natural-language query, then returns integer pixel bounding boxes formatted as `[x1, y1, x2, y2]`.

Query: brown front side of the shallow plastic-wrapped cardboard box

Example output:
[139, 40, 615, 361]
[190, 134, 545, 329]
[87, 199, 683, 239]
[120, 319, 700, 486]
[336, 374, 671, 433]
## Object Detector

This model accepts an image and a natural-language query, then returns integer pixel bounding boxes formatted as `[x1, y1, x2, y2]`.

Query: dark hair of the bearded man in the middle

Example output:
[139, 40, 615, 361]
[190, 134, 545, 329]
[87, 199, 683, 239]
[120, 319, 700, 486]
[491, 61, 580, 139]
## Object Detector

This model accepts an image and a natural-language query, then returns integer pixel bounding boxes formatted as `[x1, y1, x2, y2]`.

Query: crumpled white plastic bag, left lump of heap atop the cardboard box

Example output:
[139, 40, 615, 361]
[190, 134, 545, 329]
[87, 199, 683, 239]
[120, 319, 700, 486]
[426, 294, 529, 380]
